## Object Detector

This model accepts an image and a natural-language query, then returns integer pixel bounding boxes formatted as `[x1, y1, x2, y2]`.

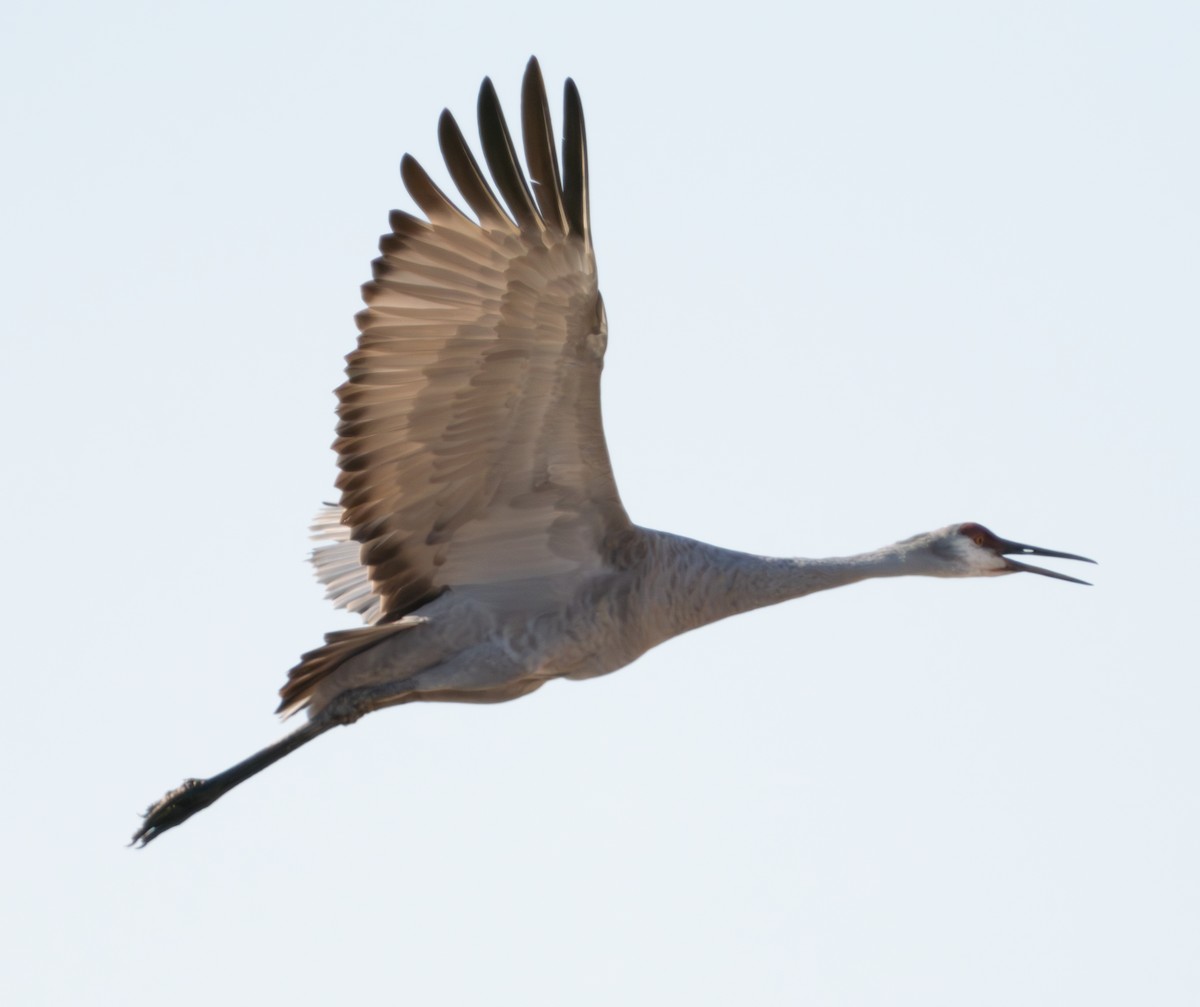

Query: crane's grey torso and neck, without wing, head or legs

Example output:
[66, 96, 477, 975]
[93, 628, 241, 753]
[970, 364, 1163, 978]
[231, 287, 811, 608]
[308, 528, 904, 717]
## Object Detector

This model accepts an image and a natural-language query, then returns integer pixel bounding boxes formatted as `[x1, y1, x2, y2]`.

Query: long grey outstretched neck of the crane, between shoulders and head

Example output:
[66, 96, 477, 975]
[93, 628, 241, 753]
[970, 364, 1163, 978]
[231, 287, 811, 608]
[653, 533, 936, 633]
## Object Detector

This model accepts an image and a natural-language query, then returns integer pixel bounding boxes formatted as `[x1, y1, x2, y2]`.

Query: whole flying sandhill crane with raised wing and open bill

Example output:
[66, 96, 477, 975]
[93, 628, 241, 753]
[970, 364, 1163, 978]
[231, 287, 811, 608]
[130, 58, 1094, 847]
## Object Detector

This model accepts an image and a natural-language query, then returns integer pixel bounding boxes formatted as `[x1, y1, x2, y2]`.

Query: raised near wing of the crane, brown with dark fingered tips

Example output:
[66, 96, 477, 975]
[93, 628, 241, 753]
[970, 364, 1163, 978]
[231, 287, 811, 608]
[335, 60, 629, 622]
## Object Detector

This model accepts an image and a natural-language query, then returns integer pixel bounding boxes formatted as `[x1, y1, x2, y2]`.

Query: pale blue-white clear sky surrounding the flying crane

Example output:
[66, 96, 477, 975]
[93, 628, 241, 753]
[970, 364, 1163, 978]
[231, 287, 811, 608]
[0, 0, 1200, 1007]
